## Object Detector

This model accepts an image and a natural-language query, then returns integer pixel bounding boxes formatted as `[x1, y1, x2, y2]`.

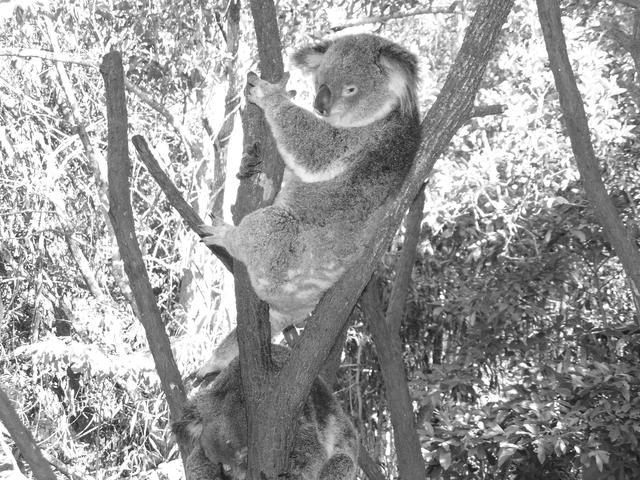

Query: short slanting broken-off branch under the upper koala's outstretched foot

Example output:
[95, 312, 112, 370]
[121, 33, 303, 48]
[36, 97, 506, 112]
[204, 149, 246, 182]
[131, 135, 233, 272]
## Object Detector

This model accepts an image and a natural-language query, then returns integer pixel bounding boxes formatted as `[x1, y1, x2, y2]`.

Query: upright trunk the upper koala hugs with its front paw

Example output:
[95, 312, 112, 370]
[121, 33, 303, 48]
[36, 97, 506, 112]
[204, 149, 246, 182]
[232, 0, 288, 480]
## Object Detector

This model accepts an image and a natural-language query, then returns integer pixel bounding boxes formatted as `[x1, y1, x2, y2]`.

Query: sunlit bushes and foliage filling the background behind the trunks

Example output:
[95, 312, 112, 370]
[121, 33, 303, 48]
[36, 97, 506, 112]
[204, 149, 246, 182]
[0, 0, 640, 480]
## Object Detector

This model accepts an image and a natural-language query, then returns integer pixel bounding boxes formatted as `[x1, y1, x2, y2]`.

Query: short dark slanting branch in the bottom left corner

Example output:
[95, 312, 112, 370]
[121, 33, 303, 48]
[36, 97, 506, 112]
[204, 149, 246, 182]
[0, 389, 56, 480]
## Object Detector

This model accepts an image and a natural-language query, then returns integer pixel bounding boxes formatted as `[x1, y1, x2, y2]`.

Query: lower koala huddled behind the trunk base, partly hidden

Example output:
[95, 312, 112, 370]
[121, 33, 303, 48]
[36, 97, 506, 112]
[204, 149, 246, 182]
[172, 345, 359, 480]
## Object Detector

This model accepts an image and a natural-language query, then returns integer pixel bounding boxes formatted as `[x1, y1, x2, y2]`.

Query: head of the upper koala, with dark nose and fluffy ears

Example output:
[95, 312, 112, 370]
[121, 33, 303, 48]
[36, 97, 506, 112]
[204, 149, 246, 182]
[293, 34, 418, 128]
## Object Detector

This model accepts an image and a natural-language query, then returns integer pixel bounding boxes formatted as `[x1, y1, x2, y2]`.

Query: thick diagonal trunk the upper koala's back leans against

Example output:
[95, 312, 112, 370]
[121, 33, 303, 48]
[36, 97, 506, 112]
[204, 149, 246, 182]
[236, 0, 513, 480]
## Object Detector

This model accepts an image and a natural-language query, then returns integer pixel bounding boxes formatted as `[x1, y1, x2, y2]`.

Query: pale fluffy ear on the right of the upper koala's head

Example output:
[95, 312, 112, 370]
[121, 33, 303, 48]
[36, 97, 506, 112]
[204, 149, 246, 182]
[377, 43, 418, 114]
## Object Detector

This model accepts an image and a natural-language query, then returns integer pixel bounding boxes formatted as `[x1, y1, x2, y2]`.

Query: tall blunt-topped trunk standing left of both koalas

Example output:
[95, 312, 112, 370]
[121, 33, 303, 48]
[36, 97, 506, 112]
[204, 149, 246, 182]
[100, 52, 187, 459]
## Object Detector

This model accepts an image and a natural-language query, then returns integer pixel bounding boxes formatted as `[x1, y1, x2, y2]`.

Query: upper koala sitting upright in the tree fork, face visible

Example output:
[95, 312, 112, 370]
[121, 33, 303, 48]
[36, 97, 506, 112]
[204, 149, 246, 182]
[198, 34, 420, 377]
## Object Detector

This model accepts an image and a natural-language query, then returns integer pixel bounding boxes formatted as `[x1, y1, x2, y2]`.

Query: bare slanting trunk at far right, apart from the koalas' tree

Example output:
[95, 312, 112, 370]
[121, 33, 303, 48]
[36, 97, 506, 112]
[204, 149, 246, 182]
[537, 0, 640, 305]
